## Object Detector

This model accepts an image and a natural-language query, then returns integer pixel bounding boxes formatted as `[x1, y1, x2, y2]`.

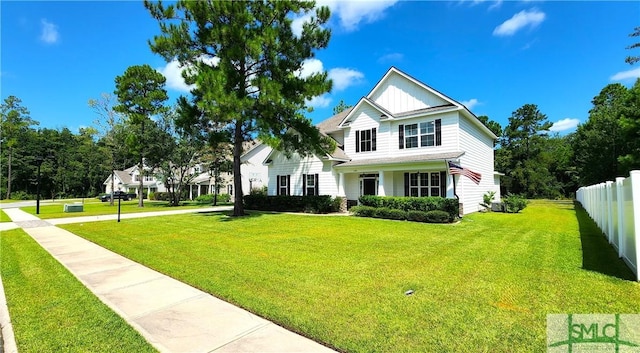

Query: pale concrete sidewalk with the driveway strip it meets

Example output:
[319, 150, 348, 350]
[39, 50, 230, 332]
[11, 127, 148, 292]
[4, 209, 334, 353]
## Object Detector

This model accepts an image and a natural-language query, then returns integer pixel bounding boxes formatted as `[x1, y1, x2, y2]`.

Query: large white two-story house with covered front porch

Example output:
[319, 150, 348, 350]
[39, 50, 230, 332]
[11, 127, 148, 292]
[243, 67, 500, 214]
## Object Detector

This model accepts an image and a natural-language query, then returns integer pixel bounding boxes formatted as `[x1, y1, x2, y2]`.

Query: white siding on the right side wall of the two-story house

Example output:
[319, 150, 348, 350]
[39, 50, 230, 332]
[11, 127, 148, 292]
[456, 115, 499, 214]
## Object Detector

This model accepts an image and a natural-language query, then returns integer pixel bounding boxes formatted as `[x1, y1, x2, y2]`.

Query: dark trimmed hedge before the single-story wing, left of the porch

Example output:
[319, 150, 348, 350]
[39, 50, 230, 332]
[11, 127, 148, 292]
[243, 194, 341, 213]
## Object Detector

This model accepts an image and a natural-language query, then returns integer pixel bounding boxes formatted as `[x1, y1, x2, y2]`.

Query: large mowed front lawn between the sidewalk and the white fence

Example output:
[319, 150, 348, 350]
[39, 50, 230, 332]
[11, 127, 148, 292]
[63, 201, 640, 352]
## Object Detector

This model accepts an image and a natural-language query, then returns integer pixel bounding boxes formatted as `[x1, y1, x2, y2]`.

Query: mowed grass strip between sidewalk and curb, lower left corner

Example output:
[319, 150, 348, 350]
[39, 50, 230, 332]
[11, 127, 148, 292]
[0, 229, 156, 353]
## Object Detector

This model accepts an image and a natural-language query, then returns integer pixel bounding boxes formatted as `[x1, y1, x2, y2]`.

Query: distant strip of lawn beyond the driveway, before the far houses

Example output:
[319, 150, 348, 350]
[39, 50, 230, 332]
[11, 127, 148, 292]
[21, 199, 211, 219]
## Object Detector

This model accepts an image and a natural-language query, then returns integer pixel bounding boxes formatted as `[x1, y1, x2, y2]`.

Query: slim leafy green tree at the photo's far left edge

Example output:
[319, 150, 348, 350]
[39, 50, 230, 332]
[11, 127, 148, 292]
[0, 96, 38, 199]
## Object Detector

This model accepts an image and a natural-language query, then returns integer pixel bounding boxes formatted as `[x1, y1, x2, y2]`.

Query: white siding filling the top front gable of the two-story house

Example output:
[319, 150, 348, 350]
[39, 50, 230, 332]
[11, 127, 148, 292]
[369, 73, 448, 114]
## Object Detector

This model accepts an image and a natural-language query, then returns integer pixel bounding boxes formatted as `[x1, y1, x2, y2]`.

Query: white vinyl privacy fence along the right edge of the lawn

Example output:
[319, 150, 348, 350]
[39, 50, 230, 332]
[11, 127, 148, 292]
[576, 170, 640, 281]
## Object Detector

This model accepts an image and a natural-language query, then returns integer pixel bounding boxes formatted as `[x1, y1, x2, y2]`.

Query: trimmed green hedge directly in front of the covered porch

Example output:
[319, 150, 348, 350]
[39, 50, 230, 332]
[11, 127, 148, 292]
[360, 195, 460, 222]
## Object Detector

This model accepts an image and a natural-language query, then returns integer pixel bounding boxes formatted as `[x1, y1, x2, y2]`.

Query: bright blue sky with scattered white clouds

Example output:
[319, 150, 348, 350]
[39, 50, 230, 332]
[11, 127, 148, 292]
[0, 0, 640, 134]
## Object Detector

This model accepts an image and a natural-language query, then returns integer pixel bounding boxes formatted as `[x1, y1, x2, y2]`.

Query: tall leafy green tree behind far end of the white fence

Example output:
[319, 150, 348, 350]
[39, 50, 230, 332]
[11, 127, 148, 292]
[572, 83, 628, 185]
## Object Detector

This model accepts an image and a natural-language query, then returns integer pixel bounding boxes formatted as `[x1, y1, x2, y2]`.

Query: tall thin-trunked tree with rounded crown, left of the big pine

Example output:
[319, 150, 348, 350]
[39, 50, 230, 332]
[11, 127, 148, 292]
[113, 64, 169, 207]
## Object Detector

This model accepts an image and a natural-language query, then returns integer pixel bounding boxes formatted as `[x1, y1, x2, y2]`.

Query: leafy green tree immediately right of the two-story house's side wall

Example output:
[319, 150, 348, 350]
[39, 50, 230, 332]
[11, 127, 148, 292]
[496, 104, 552, 198]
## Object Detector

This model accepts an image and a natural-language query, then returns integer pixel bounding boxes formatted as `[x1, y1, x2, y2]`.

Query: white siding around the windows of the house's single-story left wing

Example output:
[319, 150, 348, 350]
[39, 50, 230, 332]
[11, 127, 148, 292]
[268, 152, 338, 195]
